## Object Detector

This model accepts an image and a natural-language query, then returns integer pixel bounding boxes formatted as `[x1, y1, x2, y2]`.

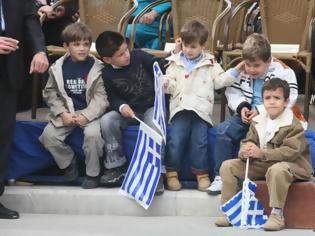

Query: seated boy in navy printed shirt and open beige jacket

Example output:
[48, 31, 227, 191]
[39, 23, 109, 189]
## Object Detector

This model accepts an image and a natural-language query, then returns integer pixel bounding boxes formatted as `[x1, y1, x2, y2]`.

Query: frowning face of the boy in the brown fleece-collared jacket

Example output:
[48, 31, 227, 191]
[263, 88, 289, 119]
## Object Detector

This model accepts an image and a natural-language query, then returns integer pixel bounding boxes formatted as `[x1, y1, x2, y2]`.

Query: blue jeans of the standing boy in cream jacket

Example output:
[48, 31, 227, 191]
[165, 110, 209, 174]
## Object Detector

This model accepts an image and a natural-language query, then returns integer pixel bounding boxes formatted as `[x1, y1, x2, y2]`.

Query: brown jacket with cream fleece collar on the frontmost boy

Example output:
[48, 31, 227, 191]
[243, 108, 313, 177]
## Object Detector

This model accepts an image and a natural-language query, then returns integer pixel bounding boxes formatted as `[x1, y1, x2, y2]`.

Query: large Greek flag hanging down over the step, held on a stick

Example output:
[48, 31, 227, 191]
[120, 121, 162, 209]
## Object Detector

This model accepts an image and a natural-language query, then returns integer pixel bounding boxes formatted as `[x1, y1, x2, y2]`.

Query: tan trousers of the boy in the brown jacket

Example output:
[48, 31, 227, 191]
[220, 159, 311, 209]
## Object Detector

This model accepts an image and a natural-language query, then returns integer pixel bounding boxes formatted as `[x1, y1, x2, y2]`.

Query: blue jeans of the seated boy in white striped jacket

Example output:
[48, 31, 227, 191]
[214, 114, 249, 176]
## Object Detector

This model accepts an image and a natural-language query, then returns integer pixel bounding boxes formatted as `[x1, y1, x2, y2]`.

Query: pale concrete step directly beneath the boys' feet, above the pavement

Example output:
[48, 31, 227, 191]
[0, 186, 220, 217]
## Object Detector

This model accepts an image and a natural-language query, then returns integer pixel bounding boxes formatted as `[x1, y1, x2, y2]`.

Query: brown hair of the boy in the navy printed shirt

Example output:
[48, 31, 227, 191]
[61, 22, 92, 44]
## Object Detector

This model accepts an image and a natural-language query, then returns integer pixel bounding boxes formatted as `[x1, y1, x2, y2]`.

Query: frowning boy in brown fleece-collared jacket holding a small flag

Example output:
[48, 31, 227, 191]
[215, 78, 312, 231]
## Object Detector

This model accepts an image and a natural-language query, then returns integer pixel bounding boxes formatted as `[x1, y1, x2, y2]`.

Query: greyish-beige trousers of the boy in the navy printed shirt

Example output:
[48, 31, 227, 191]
[39, 119, 104, 177]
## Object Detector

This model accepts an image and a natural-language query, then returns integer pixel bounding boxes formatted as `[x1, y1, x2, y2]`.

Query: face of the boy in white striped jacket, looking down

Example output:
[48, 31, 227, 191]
[245, 58, 271, 79]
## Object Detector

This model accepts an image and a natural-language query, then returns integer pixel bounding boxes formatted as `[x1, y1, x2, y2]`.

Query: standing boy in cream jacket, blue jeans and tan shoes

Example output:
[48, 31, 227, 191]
[164, 20, 236, 191]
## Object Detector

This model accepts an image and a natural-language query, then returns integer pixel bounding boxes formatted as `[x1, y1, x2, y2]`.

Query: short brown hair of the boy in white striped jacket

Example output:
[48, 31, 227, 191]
[242, 33, 271, 62]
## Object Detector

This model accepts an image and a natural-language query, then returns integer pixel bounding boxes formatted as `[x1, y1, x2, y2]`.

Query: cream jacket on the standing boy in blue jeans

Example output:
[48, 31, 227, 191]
[164, 52, 236, 125]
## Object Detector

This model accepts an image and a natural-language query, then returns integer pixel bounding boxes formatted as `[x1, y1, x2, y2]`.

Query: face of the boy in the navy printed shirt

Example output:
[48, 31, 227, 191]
[63, 40, 91, 62]
